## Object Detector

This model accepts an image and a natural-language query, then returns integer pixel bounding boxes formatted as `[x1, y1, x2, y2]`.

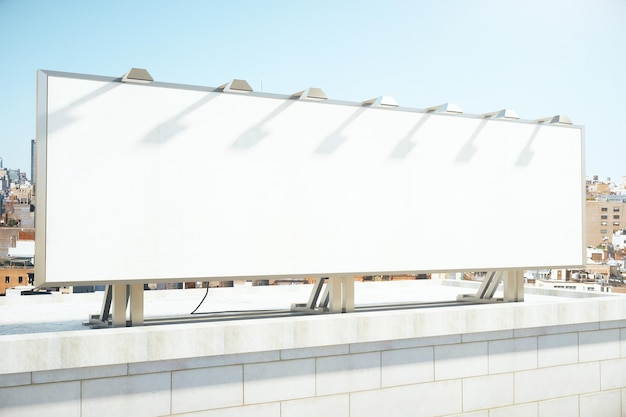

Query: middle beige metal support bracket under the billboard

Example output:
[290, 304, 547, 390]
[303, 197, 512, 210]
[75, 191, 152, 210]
[291, 276, 354, 313]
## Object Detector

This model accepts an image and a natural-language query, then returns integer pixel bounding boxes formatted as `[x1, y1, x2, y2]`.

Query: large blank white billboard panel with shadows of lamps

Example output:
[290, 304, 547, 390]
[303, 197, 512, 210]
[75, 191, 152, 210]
[35, 71, 584, 284]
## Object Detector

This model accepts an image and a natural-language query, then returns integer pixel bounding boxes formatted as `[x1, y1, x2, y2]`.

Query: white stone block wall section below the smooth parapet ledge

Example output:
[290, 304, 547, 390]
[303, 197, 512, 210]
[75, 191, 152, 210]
[0, 320, 626, 417]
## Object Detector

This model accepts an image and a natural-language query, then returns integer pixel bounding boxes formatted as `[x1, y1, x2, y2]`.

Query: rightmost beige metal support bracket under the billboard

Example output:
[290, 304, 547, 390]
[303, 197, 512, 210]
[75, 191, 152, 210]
[457, 270, 524, 303]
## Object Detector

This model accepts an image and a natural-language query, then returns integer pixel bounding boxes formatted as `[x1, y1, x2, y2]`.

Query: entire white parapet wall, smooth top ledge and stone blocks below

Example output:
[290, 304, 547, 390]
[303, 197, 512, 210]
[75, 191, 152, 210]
[0, 282, 626, 417]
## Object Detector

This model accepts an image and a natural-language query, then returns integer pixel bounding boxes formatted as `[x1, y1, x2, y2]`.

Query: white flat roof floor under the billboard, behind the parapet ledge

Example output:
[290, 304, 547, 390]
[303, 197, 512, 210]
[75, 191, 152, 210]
[0, 280, 609, 335]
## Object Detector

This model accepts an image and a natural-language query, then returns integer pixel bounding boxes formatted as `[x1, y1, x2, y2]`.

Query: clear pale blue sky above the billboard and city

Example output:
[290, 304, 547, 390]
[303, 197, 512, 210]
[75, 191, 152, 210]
[0, 0, 626, 179]
